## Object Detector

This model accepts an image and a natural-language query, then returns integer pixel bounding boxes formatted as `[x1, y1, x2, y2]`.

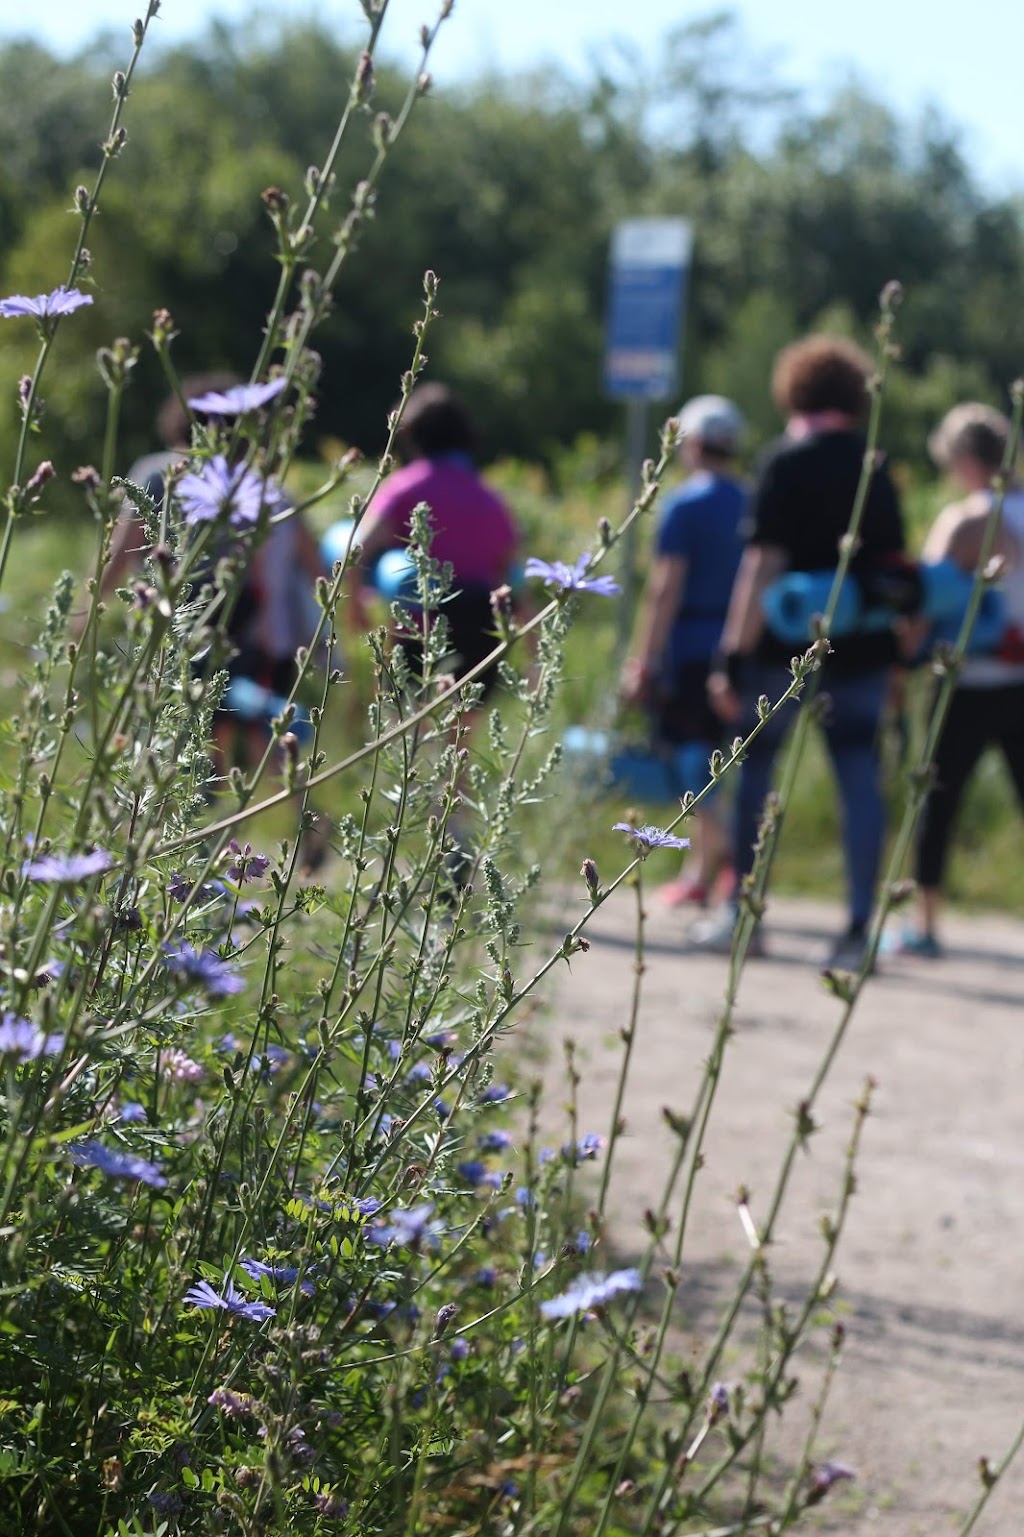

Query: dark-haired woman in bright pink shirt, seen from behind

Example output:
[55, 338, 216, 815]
[357, 384, 520, 693]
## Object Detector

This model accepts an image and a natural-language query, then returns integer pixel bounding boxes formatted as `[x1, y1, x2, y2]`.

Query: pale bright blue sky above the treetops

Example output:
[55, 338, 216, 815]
[0, 0, 1024, 191]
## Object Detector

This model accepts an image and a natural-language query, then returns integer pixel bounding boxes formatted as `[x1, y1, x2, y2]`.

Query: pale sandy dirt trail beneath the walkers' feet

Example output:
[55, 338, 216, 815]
[547, 893, 1024, 1537]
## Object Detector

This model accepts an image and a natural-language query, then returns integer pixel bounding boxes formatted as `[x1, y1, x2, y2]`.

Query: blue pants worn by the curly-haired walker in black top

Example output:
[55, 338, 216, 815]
[736, 662, 889, 924]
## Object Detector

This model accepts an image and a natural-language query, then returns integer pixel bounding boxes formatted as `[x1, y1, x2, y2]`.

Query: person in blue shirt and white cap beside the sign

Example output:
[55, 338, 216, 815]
[621, 395, 747, 907]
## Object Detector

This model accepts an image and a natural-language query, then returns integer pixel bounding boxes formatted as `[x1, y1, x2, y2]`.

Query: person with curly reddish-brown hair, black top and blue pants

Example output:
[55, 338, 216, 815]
[693, 335, 906, 970]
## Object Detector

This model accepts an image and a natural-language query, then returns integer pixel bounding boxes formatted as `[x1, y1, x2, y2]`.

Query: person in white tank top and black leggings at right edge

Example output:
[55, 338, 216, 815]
[886, 401, 1024, 958]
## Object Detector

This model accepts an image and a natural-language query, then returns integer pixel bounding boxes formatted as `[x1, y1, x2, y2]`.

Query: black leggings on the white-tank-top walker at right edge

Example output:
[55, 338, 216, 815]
[916, 682, 1024, 890]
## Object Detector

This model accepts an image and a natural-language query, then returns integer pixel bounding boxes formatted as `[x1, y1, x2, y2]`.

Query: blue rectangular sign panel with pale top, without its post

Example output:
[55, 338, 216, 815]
[604, 218, 693, 400]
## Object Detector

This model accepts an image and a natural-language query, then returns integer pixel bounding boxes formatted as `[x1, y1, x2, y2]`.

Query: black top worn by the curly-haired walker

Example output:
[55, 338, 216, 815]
[746, 432, 906, 673]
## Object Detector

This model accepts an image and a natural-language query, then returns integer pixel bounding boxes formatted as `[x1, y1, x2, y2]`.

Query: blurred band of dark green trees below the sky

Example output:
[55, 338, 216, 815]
[0, 12, 1024, 484]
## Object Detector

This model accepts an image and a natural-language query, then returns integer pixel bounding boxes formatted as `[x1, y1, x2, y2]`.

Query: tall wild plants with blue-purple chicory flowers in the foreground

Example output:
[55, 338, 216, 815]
[0, 0, 879, 1537]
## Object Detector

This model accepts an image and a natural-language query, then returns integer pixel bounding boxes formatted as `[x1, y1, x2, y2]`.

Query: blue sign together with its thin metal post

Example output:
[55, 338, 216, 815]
[604, 218, 693, 652]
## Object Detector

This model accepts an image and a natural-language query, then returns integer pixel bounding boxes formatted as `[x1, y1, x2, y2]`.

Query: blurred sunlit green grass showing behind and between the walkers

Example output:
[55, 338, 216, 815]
[0, 448, 1024, 913]
